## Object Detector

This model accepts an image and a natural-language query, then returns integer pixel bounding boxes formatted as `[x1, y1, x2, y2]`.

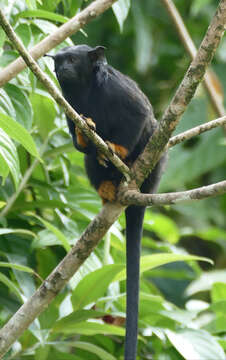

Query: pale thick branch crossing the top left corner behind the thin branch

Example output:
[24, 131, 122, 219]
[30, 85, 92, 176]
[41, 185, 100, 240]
[0, 0, 116, 87]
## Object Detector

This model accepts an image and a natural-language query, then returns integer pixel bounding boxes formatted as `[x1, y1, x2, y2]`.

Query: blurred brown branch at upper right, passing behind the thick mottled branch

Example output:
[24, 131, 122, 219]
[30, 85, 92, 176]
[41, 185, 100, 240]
[162, 0, 225, 116]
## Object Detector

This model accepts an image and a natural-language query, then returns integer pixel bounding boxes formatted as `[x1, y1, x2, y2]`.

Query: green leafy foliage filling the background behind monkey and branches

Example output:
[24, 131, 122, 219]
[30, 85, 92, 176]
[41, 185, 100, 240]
[0, 0, 226, 360]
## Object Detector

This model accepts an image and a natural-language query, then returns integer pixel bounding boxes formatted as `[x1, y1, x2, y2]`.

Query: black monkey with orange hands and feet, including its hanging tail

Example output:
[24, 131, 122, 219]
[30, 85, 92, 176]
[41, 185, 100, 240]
[46, 45, 164, 360]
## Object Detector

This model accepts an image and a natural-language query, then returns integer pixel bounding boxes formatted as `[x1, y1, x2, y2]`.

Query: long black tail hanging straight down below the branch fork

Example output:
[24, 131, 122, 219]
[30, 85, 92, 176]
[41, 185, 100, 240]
[125, 206, 145, 360]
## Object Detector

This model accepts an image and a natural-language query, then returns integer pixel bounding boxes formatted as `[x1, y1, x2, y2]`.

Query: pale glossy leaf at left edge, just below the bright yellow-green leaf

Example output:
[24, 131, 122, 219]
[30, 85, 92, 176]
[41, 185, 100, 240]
[0, 128, 20, 188]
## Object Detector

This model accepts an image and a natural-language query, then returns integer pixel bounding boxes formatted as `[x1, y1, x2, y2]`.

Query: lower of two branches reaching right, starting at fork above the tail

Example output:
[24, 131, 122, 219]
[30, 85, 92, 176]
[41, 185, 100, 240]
[120, 180, 226, 206]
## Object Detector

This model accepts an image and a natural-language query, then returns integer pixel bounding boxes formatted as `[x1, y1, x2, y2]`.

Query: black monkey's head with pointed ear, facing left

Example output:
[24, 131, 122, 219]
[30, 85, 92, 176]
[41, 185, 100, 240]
[46, 45, 107, 86]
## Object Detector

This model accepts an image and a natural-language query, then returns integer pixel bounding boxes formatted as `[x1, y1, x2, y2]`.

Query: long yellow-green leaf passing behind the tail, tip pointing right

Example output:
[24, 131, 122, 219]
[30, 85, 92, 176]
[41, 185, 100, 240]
[115, 253, 213, 281]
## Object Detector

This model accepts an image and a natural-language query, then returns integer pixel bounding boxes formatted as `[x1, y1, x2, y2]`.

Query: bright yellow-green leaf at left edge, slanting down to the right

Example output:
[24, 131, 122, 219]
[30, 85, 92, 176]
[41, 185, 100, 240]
[0, 113, 41, 160]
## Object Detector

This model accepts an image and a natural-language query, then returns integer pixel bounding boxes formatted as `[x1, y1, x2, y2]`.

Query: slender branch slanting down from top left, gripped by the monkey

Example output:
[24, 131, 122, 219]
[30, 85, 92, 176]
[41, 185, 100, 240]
[0, 8, 130, 180]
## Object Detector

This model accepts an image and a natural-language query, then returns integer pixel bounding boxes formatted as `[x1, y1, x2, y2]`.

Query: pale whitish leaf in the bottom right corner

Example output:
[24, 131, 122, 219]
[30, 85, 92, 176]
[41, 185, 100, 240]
[166, 329, 225, 360]
